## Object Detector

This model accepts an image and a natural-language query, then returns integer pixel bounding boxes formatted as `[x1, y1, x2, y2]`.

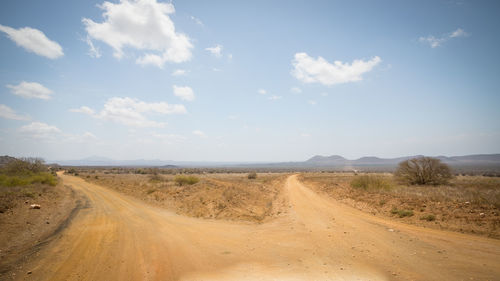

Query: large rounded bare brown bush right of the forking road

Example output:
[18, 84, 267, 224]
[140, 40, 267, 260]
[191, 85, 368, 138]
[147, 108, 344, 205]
[394, 157, 452, 185]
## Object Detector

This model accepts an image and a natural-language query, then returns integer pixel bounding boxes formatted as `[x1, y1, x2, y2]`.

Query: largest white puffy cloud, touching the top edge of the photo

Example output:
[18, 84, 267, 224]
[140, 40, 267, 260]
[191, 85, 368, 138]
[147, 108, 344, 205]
[82, 0, 193, 68]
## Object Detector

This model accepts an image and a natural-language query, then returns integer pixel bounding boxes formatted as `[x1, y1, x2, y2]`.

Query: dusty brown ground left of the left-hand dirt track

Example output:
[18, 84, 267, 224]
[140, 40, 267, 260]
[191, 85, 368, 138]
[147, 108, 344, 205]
[0, 183, 77, 279]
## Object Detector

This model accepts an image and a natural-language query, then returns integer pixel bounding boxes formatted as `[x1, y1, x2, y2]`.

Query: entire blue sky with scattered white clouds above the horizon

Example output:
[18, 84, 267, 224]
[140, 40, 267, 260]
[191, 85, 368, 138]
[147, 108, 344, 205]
[0, 0, 500, 161]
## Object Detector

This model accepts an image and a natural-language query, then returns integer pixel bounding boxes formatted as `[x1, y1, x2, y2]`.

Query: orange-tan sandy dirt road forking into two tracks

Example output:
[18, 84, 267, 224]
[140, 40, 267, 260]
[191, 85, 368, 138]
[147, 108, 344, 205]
[13, 175, 500, 280]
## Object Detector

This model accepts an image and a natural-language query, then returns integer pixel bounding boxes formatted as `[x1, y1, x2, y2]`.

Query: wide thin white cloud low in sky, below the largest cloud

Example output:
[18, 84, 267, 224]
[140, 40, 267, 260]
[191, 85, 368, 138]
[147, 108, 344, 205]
[70, 97, 187, 127]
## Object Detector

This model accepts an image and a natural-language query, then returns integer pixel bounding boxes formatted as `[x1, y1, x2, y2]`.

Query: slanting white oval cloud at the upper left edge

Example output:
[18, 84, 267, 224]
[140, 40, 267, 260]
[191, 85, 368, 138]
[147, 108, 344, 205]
[0, 24, 64, 59]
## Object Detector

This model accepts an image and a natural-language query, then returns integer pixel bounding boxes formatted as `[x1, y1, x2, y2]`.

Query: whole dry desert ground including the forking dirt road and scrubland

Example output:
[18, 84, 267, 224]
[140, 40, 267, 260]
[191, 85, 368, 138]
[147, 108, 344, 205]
[0, 158, 500, 280]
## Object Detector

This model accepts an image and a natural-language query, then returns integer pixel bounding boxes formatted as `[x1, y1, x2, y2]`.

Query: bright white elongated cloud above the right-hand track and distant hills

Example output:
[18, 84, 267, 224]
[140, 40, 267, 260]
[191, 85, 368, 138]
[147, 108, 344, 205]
[291, 53, 382, 86]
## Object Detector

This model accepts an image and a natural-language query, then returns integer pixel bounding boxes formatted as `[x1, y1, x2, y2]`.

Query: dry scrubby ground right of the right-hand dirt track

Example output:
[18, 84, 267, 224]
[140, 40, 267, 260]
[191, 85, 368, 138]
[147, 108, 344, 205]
[300, 173, 500, 239]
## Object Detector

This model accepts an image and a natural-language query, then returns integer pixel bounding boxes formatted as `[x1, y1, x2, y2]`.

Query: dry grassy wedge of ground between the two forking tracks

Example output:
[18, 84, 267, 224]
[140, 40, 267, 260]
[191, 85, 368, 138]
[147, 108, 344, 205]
[79, 172, 286, 222]
